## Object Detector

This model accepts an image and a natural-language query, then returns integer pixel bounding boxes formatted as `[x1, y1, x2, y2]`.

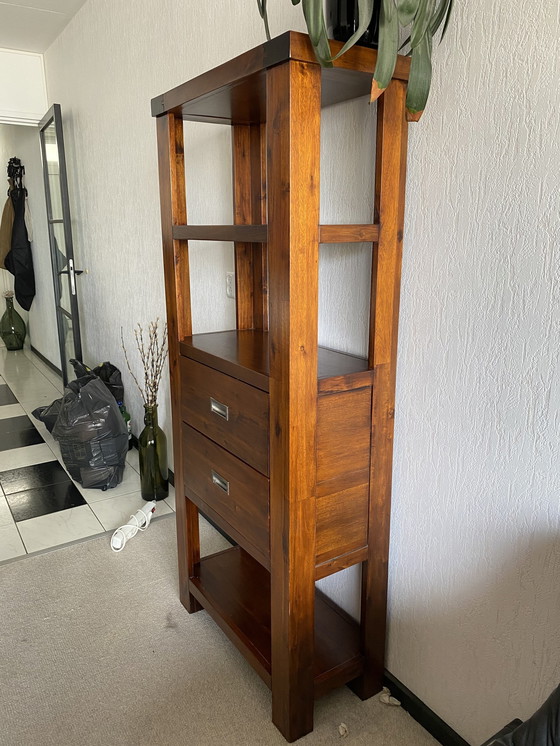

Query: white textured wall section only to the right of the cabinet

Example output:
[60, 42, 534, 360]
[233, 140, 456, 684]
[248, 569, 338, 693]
[389, 0, 560, 744]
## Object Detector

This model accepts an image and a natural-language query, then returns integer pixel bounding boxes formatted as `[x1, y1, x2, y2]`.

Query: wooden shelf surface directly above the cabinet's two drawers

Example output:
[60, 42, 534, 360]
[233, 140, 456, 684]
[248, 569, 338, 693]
[179, 329, 371, 392]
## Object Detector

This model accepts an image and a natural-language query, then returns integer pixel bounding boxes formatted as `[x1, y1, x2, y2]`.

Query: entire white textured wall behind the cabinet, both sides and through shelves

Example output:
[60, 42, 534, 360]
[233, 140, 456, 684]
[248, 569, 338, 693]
[46, 0, 560, 744]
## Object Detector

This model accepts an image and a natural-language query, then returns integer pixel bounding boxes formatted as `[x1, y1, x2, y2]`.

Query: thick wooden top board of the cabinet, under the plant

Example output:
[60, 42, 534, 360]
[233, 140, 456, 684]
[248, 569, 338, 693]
[152, 31, 410, 124]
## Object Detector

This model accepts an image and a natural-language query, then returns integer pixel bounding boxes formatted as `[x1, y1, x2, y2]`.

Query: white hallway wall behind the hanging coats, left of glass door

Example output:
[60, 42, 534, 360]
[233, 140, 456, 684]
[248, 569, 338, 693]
[0, 123, 60, 367]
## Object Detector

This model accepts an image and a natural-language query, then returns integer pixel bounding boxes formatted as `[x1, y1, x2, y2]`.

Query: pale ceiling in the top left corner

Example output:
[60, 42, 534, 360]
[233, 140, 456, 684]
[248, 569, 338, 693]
[0, 0, 86, 52]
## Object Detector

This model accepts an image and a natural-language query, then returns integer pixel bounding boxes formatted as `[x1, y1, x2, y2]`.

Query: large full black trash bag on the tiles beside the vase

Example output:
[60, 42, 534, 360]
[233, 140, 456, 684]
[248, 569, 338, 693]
[52, 374, 128, 490]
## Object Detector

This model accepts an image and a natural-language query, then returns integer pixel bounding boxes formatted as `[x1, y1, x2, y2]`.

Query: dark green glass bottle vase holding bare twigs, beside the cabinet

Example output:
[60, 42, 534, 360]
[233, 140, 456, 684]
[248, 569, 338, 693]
[138, 404, 169, 500]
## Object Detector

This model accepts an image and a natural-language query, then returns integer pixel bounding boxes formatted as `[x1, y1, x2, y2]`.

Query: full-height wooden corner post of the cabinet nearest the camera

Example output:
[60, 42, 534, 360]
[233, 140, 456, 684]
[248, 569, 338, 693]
[267, 61, 321, 741]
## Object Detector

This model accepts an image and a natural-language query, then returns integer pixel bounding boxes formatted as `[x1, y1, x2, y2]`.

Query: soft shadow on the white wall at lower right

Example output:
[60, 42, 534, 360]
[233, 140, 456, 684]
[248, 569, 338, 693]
[388, 534, 560, 746]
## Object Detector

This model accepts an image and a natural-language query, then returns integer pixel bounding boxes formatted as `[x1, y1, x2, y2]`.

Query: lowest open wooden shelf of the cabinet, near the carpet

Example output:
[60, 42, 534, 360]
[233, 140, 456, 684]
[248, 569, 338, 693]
[189, 547, 363, 697]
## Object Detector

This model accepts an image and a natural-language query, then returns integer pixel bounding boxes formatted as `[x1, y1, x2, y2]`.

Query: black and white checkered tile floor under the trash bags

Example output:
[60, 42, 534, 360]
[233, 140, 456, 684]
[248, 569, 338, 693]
[0, 347, 175, 562]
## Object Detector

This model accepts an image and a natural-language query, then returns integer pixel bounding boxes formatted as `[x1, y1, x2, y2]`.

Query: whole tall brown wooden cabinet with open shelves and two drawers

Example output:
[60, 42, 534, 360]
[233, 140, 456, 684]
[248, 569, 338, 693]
[152, 32, 409, 741]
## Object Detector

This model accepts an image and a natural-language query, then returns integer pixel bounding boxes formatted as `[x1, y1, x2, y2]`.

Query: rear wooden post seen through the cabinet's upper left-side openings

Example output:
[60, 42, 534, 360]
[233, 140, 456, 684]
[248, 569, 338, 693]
[233, 124, 268, 329]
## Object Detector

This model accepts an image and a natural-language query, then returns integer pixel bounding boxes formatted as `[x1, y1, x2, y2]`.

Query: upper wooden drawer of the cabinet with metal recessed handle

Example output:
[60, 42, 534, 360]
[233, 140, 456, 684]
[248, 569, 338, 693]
[181, 356, 269, 476]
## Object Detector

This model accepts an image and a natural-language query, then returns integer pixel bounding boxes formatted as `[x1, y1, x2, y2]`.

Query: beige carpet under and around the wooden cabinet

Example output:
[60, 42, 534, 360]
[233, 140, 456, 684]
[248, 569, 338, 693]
[0, 517, 436, 746]
